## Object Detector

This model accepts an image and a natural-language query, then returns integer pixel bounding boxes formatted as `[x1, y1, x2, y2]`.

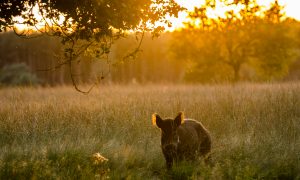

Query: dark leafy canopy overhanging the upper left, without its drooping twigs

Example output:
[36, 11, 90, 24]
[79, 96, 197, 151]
[0, 0, 182, 36]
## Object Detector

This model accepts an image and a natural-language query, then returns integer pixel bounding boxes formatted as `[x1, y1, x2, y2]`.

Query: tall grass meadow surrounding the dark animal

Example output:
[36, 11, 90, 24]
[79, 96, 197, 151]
[0, 83, 300, 179]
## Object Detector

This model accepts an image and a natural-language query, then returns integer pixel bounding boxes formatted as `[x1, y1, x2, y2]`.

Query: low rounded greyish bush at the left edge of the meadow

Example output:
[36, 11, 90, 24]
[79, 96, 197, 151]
[0, 63, 41, 86]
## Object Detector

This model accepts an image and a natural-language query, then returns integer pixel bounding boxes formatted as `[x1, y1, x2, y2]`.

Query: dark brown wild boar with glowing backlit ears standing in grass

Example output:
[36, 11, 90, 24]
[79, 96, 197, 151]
[152, 112, 211, 169]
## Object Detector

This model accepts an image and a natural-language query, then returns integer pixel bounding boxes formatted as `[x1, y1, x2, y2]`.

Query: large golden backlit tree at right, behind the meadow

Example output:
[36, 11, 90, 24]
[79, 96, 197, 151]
[172, 0, 292, 82]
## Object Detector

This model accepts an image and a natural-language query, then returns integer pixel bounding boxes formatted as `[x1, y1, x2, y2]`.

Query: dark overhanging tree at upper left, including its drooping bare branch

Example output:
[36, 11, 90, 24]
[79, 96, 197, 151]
[0, 0, 183, 92]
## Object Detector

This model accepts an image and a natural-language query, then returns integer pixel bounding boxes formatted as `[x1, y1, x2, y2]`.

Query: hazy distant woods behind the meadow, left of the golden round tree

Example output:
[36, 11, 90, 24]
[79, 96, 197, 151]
[0, 32, 183, 85]
